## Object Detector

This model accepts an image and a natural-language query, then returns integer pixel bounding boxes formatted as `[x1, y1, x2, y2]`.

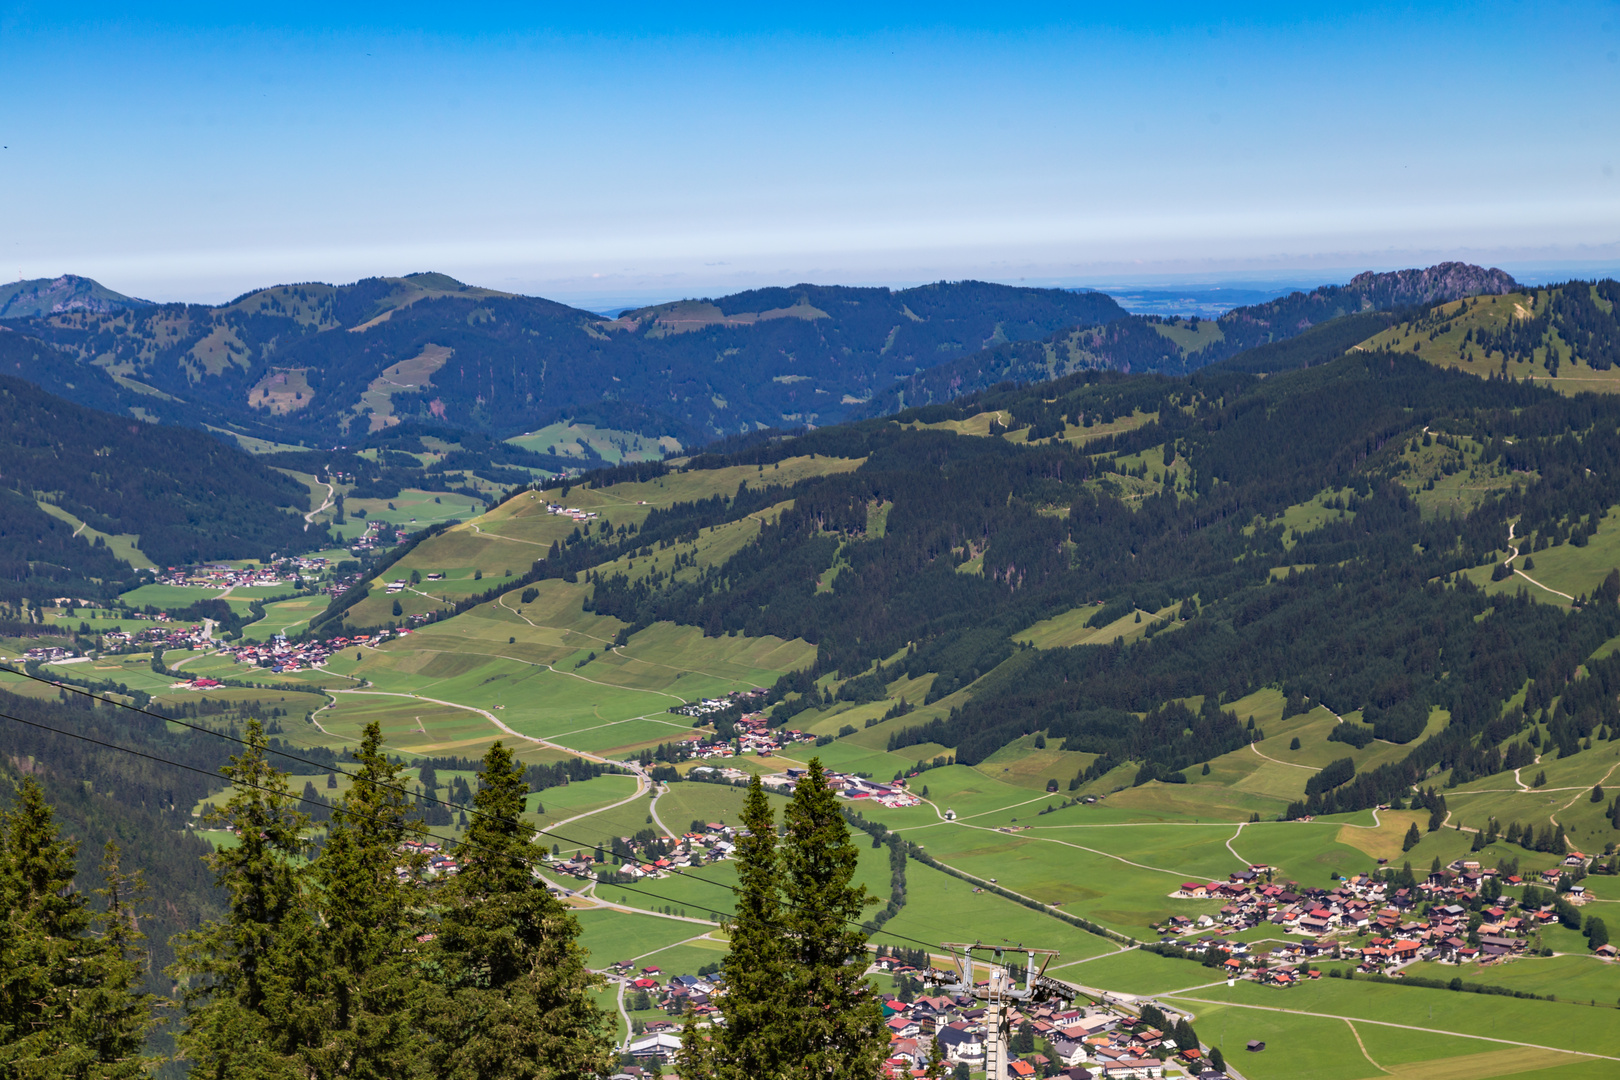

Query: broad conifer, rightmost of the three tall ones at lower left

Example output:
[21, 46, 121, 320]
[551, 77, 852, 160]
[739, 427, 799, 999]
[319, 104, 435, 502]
[423, 742, 614, 1080]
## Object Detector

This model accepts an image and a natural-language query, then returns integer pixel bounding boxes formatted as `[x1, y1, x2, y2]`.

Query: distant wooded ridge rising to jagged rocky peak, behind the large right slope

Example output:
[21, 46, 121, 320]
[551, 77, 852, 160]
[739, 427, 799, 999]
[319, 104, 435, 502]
[862, 262, 1516, 416]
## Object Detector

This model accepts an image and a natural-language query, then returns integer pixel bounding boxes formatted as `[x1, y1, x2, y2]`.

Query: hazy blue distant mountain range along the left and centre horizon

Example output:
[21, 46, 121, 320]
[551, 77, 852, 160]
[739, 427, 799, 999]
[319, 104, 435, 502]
[10, 274, 1124, 445]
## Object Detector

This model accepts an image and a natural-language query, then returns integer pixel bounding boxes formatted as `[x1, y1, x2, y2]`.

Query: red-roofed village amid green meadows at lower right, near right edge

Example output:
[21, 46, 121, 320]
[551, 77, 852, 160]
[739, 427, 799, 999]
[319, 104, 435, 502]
[1158, 853, 1584, 986]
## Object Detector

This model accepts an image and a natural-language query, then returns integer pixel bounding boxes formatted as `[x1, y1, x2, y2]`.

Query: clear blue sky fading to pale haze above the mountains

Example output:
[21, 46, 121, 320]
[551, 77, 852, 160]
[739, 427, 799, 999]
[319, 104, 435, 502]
[0, 2, 1620, 306]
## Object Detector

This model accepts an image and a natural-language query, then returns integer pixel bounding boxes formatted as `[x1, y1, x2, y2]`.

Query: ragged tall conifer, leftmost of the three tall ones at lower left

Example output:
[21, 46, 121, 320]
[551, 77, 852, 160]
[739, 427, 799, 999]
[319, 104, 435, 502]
[168, 721, 308, 1077]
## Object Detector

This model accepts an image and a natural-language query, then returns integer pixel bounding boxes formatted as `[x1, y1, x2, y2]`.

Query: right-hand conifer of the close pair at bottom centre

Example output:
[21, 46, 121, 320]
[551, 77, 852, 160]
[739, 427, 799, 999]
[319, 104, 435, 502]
[782, 758, 888, 1080]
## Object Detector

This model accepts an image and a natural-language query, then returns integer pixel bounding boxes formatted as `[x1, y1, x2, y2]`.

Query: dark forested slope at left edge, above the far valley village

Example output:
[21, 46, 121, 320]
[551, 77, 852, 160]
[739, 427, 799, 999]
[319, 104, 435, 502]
[0, 378, 327, 599]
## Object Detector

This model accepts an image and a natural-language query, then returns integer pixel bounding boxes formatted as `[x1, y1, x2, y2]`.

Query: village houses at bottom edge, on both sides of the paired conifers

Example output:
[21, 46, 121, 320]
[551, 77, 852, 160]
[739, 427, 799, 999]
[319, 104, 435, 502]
[609, 957, 1221, 1080]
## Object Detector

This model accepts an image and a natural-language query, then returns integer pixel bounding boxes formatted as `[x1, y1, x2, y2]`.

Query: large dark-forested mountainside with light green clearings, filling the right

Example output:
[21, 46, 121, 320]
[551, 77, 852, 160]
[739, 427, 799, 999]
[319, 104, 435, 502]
[370, 340, 1620, 805]
